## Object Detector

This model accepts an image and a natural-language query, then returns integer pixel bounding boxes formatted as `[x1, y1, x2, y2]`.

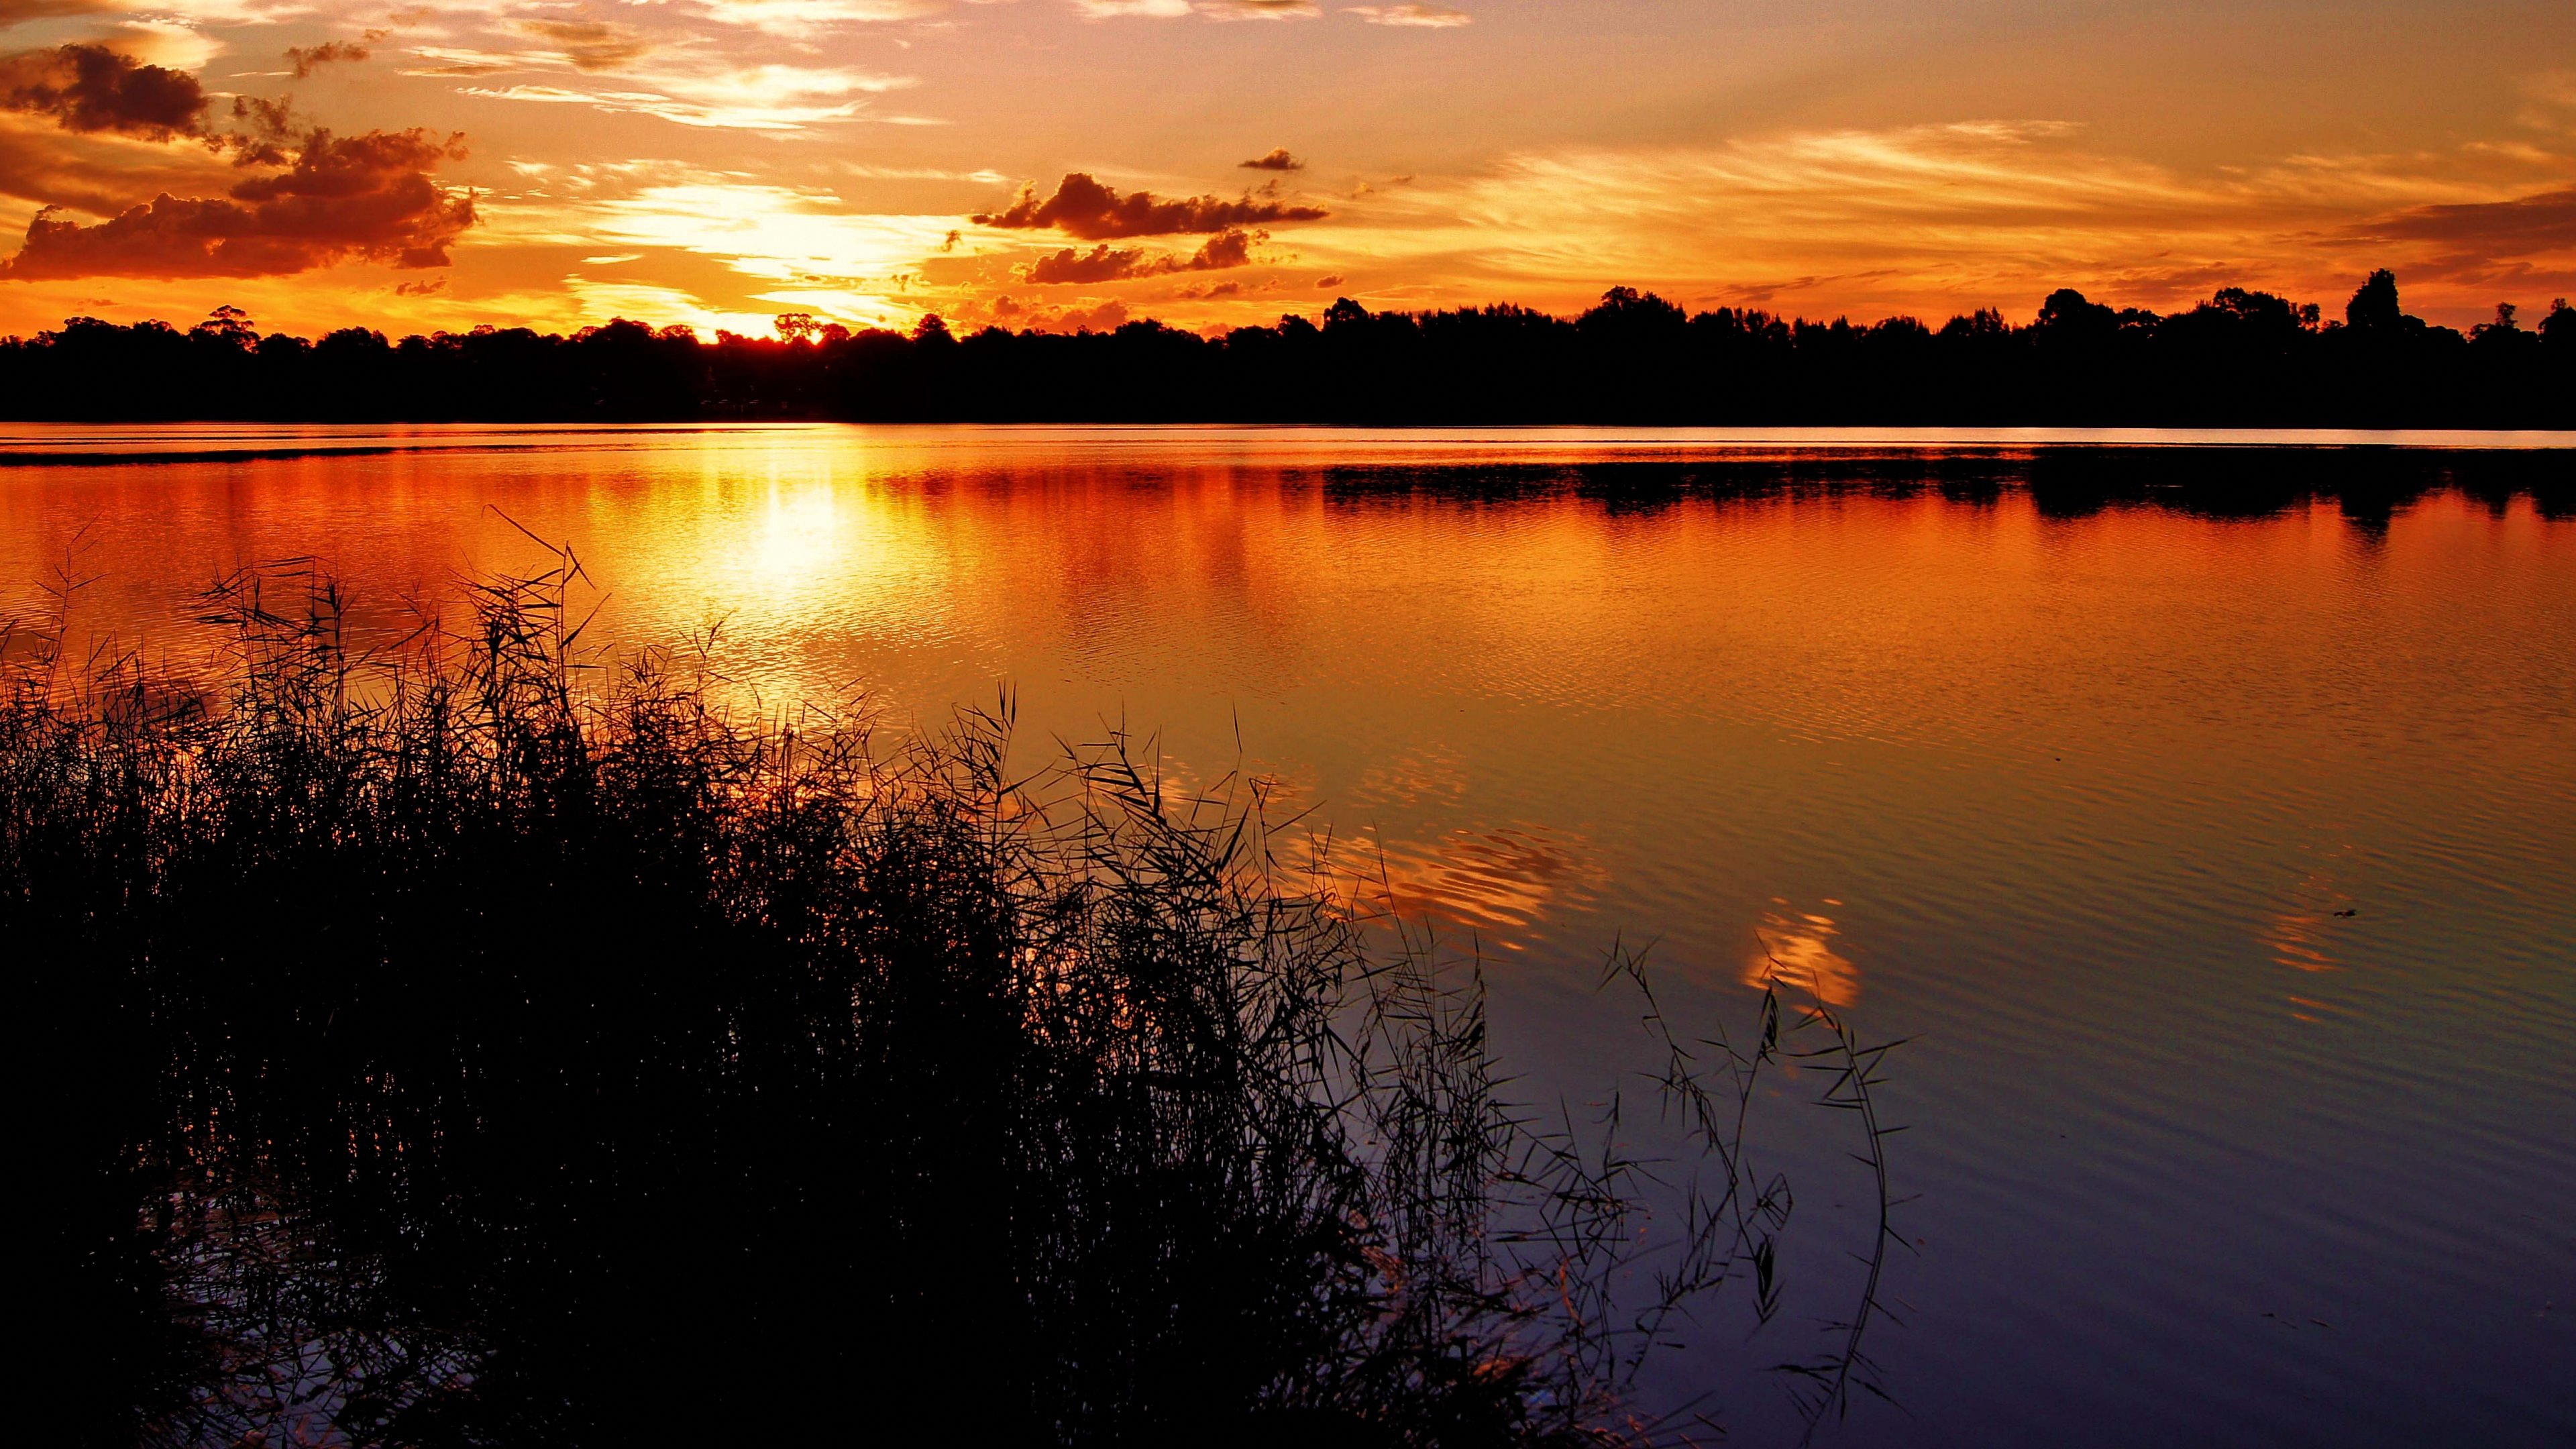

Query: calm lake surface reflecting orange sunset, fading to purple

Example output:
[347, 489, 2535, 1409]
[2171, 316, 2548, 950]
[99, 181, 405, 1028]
[0, 428, 2576, 1444]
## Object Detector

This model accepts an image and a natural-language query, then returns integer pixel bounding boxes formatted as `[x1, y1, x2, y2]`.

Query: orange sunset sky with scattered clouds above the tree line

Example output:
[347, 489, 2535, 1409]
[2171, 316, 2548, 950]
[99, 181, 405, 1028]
[0, 0, 2576, 333]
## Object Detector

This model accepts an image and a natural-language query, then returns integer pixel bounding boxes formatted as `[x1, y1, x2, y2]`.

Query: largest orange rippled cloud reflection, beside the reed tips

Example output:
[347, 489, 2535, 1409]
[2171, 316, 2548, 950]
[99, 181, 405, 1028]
[1360, 825, 1610, 951]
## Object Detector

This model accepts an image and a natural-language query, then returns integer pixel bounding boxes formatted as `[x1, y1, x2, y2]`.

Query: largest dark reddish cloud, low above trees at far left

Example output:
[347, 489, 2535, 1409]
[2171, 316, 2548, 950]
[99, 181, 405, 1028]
[0, 129, 474, 278]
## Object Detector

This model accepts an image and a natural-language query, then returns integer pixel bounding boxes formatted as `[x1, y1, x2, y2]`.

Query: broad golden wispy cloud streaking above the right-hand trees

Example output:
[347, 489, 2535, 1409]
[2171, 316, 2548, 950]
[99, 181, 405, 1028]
[1301, 121, 2576, 312]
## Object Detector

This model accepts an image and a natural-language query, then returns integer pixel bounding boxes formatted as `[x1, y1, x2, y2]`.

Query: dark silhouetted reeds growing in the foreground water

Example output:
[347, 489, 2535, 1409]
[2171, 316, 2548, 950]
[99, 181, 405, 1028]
[0, 554, 1898, 1446]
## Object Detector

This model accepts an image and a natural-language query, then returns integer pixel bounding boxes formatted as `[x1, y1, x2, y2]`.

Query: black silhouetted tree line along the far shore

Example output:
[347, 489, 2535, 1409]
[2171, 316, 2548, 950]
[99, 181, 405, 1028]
[0, 271, 2576, 428]
